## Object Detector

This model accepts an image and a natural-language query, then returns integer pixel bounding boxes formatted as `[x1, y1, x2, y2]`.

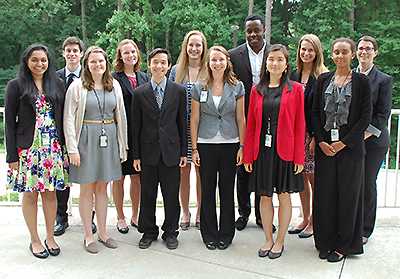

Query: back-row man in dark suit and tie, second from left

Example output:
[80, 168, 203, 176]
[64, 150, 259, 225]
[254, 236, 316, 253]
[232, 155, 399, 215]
[54, 37, 97, 236]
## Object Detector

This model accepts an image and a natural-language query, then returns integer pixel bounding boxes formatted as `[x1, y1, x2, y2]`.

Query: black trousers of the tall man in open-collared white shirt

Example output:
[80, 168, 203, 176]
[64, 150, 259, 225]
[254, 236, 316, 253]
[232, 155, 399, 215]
[236, 165, 261, 222]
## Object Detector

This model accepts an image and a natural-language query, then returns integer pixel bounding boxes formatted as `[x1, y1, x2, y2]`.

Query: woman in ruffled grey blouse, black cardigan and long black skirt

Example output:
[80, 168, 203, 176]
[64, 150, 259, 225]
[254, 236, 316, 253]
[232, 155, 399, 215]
[313, 38, 371, 262]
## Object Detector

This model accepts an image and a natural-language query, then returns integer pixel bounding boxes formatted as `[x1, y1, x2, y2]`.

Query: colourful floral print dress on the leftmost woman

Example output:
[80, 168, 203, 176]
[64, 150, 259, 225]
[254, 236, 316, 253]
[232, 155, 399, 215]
[7, 94, 68, 192]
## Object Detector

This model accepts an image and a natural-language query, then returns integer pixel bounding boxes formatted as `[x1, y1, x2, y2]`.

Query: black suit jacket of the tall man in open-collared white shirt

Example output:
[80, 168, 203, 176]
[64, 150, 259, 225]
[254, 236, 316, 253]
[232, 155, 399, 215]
[229, 43, 268, 116]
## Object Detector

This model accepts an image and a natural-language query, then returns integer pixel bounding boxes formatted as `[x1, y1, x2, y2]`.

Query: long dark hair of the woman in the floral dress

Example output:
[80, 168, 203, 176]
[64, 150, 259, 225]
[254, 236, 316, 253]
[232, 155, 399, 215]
[18, 44, 64, 101]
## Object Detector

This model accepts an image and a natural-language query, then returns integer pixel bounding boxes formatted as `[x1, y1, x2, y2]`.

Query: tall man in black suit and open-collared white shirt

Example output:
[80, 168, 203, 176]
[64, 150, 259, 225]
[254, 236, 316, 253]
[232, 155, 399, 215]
[229, 15, 268, 231]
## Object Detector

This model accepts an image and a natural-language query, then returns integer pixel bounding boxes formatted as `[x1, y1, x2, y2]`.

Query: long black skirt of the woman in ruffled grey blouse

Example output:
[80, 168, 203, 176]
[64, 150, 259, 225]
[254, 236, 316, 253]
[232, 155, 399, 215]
[313, 147, 364, 255]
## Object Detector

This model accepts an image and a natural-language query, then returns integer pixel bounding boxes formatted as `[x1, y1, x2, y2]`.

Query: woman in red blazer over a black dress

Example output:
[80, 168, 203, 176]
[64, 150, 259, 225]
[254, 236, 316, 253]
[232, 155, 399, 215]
[243, 44, 305, 259]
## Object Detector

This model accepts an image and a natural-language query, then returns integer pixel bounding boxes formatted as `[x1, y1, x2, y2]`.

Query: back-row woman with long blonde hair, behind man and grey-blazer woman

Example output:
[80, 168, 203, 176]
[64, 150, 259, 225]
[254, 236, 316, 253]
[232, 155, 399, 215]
[169, 30, 207, 230]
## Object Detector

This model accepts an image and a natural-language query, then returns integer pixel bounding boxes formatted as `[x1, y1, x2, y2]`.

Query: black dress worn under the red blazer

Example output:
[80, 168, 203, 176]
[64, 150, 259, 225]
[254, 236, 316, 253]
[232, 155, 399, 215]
[249, 87, 304, 197]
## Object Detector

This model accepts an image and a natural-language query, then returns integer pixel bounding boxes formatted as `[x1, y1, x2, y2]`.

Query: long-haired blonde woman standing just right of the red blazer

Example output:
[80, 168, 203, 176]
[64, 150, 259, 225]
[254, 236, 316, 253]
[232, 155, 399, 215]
[289, 34, 328, 238]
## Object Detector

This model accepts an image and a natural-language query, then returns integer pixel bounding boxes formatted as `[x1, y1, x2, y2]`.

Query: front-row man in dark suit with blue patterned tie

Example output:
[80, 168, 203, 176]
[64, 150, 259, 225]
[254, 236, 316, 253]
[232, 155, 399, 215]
[132, 48, 187, 252]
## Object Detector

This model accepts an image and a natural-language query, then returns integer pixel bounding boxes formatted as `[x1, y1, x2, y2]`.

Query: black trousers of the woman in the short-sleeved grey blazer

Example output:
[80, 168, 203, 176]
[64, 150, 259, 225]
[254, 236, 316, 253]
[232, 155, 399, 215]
[197, 143, 239, 243]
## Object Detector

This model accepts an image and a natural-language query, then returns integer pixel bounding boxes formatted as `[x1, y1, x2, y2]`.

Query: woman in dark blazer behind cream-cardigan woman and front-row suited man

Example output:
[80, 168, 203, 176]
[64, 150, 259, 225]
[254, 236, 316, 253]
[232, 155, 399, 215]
[113, 39, 149, 234]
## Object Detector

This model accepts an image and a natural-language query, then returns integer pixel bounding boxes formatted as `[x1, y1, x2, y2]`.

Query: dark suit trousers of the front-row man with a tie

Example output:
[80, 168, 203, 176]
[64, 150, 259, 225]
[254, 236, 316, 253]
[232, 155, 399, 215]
[138, 159, 180, 239]
